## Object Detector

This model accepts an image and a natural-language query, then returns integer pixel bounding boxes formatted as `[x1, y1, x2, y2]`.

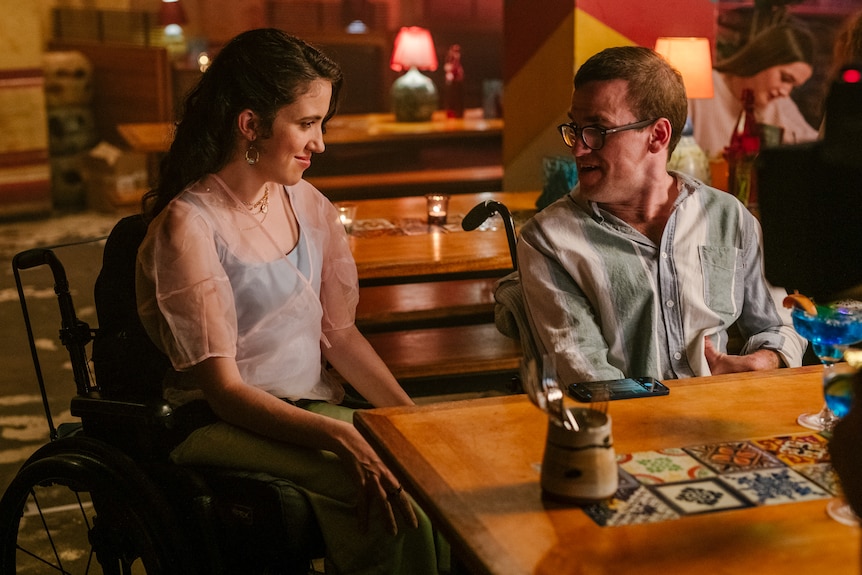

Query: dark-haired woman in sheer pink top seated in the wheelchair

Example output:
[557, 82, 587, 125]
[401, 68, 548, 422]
[136, 29, 446, 574]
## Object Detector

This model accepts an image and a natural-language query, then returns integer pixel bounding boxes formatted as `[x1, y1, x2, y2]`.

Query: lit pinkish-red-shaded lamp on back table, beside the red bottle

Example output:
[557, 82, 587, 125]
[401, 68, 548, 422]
[389, 26, 439, 122]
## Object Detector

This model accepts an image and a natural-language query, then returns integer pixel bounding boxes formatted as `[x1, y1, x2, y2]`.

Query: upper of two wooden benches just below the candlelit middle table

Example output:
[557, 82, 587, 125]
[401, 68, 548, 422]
[356, 278, 497, 334]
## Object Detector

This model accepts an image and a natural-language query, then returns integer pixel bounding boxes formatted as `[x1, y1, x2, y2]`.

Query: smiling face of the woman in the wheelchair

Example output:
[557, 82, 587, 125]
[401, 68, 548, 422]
[255, 80, 332, 186]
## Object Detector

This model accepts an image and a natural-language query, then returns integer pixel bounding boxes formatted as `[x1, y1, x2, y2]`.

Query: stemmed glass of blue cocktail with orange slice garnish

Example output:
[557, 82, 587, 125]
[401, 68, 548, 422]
[790, 304, 862, 431]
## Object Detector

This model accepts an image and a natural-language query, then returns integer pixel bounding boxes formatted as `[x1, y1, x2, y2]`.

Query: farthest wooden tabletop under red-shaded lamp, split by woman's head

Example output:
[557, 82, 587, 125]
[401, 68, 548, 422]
[117, 109, 503, 153]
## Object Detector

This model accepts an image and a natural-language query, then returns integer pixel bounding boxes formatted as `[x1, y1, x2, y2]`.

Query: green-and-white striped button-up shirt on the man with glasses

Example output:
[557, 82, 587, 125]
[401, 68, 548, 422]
[518, 172, 807, 383]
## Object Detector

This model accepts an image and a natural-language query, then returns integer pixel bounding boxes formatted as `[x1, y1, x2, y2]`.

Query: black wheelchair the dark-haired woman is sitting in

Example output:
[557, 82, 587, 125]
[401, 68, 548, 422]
[0, 216, 325, 575]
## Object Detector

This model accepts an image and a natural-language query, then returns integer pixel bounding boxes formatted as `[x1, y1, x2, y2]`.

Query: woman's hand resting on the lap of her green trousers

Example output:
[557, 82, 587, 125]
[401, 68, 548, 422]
[340, 429, 419, 535]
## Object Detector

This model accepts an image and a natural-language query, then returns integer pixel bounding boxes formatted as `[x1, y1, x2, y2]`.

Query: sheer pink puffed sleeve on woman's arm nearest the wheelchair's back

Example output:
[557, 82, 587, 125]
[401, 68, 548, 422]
[136, 201, 237, 370]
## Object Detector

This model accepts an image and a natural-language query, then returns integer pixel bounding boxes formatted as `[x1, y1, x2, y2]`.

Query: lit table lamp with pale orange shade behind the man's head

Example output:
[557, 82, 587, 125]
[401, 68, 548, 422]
[655, 38, 713, 184]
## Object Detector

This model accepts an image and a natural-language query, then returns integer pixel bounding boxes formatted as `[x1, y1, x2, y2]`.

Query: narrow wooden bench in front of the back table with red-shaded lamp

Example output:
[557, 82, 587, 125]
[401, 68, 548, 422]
[307, 166, 503, 202]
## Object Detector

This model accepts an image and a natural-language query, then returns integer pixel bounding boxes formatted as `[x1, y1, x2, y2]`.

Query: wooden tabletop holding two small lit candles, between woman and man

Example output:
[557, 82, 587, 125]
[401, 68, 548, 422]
[350, 192, 539, 285]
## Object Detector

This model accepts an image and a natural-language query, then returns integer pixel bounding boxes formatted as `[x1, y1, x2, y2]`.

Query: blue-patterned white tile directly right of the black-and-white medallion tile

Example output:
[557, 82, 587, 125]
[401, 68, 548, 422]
[721, 467, 832, 505]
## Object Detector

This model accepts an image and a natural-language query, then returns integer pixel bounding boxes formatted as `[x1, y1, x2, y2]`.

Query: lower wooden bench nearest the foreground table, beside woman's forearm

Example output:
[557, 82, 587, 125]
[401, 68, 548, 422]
[332, 323, 521, 397]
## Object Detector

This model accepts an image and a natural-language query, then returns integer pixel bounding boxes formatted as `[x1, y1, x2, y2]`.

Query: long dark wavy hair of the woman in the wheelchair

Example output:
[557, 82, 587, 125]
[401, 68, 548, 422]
[143, 28, 343, 218]
